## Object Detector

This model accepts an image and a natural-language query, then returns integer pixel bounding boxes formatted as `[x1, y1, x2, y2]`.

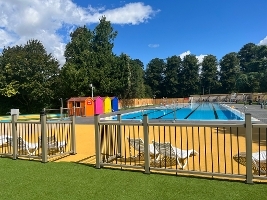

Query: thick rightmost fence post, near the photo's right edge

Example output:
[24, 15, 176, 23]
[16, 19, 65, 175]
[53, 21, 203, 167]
[245, 113, 253, 184]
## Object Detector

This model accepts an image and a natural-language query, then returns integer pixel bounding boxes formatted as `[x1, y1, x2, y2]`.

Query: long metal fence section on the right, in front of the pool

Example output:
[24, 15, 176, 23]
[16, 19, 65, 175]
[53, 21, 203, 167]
[95, 113, 267, 183]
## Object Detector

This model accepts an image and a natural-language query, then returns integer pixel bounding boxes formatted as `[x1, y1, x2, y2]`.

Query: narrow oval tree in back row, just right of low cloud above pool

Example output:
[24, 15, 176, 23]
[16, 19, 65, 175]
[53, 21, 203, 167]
[200, 55, 219, 94]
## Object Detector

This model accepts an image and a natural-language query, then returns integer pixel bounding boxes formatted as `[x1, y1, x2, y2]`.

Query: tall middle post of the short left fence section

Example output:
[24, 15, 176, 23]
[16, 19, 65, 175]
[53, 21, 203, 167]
[40, 111, 48, 163]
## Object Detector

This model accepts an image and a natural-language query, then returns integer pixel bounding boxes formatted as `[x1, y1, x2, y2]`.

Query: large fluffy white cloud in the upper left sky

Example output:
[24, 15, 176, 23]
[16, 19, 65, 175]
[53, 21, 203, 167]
[0, 0, 158, 64]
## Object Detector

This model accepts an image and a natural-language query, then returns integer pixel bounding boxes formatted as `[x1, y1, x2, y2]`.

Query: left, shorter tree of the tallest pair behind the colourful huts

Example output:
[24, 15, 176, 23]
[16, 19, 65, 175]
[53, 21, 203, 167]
[61, 26, 97, 98]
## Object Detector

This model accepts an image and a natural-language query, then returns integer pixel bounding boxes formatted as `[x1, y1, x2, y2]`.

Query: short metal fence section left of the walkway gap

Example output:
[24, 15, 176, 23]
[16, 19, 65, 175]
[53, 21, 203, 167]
[0, 114, 76, 162]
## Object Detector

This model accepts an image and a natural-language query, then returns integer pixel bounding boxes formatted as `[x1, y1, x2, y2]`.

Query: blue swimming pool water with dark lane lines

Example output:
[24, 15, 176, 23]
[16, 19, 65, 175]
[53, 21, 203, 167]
[112, 103, 243, 120]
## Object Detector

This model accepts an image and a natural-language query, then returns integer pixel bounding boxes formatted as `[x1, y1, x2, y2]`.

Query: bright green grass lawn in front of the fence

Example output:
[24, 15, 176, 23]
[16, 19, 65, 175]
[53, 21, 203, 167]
[0, 158, 267, 200]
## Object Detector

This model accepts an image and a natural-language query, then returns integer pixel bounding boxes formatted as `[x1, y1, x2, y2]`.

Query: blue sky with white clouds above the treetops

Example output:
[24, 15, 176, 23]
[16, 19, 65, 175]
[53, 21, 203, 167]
[0, 0, 267, 65]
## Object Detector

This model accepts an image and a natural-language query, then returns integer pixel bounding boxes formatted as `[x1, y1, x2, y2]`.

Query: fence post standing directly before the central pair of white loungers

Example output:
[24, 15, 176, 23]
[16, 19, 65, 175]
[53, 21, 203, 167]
[143, 114, 150, 174]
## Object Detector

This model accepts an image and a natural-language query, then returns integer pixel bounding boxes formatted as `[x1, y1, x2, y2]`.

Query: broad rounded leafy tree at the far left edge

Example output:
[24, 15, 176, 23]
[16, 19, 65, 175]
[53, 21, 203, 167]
[0, 40, 59, 113]
